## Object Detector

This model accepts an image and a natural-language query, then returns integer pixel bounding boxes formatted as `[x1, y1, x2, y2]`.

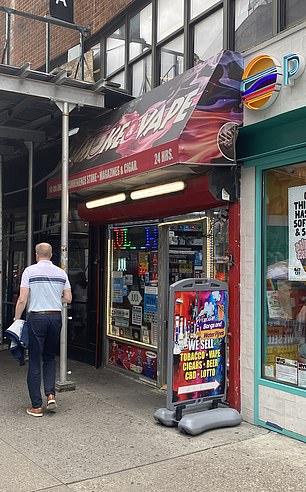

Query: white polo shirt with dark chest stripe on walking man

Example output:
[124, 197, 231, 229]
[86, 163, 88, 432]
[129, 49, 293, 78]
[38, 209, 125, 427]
[20, 260, 71, 312]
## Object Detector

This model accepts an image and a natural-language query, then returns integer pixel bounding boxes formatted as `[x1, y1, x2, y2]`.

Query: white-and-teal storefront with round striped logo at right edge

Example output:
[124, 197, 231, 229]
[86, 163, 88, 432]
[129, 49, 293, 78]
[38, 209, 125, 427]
[237, 32, 306, 441]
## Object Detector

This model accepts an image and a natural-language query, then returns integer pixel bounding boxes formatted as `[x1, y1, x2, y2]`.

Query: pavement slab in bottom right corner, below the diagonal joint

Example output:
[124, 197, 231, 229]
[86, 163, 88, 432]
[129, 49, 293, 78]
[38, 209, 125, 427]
[65, 435, 306, 492]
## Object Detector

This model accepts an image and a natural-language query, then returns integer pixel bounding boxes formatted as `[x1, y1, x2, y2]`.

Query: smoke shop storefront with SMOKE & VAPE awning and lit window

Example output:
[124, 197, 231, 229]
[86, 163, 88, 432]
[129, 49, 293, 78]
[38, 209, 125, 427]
[48, 51, 242, 406]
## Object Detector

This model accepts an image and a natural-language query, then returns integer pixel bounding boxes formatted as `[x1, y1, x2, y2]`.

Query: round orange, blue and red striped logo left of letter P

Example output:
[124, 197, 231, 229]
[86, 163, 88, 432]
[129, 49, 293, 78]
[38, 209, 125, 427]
[241, 55, 282, 110]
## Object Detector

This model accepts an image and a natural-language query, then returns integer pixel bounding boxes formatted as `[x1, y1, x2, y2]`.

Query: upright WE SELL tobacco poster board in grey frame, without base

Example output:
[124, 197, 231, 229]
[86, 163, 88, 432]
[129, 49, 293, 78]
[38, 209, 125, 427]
[167, 278, 228, 413]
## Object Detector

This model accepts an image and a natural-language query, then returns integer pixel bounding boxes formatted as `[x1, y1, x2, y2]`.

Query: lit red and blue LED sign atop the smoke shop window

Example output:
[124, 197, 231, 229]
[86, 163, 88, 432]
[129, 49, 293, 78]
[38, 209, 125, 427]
[113, 226, 158, 250]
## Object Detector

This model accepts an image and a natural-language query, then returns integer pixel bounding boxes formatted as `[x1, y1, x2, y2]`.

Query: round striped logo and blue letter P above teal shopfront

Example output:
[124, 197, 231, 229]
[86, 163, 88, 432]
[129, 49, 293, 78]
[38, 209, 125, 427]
[240, 53, 305, 111]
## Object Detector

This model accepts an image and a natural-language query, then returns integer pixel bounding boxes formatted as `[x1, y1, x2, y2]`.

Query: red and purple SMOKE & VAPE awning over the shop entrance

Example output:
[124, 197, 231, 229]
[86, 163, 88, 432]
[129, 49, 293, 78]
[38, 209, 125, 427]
[48, 51, 243, 197]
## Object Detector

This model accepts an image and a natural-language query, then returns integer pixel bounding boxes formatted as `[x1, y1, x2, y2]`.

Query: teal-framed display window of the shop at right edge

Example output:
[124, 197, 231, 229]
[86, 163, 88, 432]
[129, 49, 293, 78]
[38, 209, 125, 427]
[262, 163, 306, 388]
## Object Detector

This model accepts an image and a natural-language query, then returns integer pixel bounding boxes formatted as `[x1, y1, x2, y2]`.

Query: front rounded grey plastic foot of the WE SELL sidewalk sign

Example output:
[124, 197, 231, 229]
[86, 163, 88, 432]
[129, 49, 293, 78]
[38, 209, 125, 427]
[177, 408, 242, 436]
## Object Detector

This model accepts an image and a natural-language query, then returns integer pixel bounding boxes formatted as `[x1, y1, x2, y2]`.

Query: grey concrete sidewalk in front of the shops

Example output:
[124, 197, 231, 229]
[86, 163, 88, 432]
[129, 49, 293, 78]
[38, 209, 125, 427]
[0, 351, 306, 492]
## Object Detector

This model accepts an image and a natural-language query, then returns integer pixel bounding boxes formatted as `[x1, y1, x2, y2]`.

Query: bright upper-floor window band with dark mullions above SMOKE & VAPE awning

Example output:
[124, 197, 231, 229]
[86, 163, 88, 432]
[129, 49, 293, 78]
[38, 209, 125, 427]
[99, 0, 229, 97]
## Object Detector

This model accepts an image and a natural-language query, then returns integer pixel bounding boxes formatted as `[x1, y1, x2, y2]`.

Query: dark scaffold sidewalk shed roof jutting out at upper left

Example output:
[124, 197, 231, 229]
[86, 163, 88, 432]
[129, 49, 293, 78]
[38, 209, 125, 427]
[0, 63, 131, 156]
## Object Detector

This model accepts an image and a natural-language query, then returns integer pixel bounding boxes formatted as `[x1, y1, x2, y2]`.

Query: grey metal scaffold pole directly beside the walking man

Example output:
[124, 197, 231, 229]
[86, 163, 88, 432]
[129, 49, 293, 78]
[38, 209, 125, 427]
[57, 102, 75, 391]
